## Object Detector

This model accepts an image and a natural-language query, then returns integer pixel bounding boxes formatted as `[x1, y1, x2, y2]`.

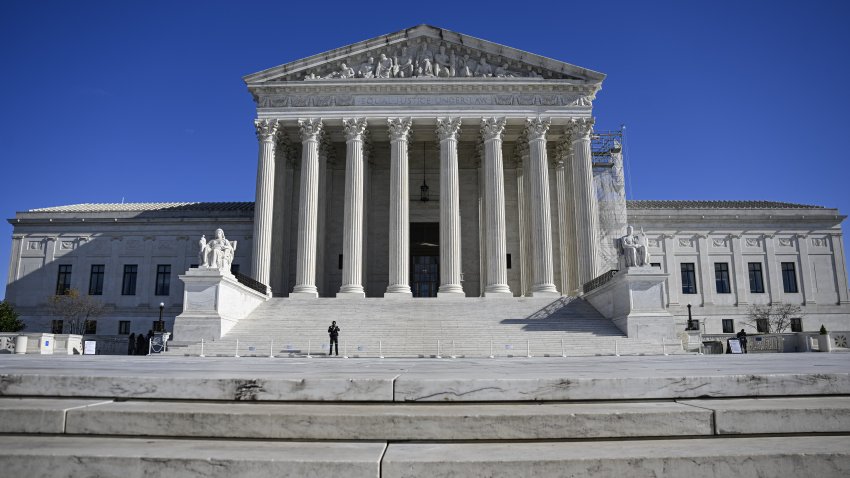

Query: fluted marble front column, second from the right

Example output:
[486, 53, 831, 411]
[527, 118, 561, 297]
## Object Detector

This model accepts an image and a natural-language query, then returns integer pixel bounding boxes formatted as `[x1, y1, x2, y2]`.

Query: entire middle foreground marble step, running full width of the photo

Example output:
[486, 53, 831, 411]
[0, 396, 850, 441]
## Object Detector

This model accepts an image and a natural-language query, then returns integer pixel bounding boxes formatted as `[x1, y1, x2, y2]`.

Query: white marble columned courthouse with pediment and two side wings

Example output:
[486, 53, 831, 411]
[6, 25, 850, 334]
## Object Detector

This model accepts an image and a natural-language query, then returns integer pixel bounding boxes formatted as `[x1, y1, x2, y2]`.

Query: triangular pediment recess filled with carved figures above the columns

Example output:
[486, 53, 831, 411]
[288, 38, 569, 80]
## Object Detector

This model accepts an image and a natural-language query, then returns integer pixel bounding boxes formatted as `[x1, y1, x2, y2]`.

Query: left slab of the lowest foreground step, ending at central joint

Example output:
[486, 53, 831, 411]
[0, 435, 385, 478]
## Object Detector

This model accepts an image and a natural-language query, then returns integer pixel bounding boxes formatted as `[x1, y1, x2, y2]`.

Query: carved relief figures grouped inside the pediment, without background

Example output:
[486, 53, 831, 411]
[304, 38, 542, 80]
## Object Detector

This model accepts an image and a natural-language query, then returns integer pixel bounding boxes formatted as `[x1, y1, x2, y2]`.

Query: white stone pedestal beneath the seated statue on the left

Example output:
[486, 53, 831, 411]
[174, 268, 268, 342]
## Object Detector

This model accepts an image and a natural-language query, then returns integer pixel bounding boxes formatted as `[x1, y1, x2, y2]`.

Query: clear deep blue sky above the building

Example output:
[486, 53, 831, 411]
[0, 0, 850, 297]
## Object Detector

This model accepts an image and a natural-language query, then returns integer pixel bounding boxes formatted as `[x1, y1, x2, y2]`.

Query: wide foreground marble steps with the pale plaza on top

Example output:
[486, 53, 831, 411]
[0, 354, 850, 478]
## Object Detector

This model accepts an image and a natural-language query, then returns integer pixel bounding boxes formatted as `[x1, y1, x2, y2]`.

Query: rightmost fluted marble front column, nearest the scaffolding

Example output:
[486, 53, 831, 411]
[569, 119, 599, 287]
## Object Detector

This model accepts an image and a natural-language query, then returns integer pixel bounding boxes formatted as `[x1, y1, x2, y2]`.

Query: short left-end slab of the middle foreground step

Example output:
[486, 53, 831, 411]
[0, 398, 111, 433]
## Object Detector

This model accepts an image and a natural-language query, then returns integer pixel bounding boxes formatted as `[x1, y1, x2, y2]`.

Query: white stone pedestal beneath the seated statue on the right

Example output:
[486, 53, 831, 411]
[584, 266, 676, 341]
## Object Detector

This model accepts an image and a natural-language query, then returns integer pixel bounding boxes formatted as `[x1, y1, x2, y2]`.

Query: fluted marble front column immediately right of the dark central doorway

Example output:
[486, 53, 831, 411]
[437, 118, 465, 297]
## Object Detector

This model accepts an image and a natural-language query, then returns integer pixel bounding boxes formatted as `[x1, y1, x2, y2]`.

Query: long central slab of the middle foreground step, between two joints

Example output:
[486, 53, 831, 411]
[66, 401, 713, 440]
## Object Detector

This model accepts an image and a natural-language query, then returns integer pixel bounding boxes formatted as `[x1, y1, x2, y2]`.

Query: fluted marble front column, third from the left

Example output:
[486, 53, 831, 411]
[336, 118, 366, 298]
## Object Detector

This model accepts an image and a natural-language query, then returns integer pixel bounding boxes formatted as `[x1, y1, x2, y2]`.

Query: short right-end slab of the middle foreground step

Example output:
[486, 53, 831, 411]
[680, 397, 850, 435]
